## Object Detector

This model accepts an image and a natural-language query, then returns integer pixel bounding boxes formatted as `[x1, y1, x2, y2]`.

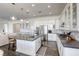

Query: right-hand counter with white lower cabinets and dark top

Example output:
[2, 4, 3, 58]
[57, 34, 79, 56]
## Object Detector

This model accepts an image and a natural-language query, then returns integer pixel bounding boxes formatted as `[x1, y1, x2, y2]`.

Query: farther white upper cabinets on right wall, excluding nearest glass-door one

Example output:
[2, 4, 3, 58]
[60, 4, 71, 30]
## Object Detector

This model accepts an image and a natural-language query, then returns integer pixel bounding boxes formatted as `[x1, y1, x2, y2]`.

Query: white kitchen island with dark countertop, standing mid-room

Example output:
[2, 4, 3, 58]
[16, 35, 43, 56]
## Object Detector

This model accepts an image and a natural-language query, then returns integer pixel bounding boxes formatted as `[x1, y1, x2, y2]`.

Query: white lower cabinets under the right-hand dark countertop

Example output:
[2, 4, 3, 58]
[57, 37, 79, 56]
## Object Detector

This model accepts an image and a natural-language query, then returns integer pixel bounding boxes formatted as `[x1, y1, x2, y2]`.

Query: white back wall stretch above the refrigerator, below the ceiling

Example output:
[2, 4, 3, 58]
[29, 16, 59, 30]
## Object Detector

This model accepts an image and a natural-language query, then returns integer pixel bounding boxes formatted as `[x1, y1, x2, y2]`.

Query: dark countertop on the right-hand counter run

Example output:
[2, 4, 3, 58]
[57, 34, 79, 49]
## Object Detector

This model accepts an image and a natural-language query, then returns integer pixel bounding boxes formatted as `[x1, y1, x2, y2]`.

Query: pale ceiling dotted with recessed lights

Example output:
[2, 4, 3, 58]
[0, 3, 66, 20]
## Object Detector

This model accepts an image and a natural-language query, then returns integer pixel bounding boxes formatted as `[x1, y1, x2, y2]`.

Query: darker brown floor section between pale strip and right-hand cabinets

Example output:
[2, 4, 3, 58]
[45, 42, 58, 56]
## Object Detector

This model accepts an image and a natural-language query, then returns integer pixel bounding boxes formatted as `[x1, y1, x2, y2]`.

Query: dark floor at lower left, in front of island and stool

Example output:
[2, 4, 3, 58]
[0, 44, 28, 56]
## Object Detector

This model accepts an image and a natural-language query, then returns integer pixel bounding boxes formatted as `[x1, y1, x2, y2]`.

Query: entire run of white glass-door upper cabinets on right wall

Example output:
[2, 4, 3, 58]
[59, 3, 78, 30]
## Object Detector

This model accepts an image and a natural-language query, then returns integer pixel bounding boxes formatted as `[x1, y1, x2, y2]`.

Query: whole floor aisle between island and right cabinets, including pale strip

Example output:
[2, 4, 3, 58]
[38, 42, 59, 56]
